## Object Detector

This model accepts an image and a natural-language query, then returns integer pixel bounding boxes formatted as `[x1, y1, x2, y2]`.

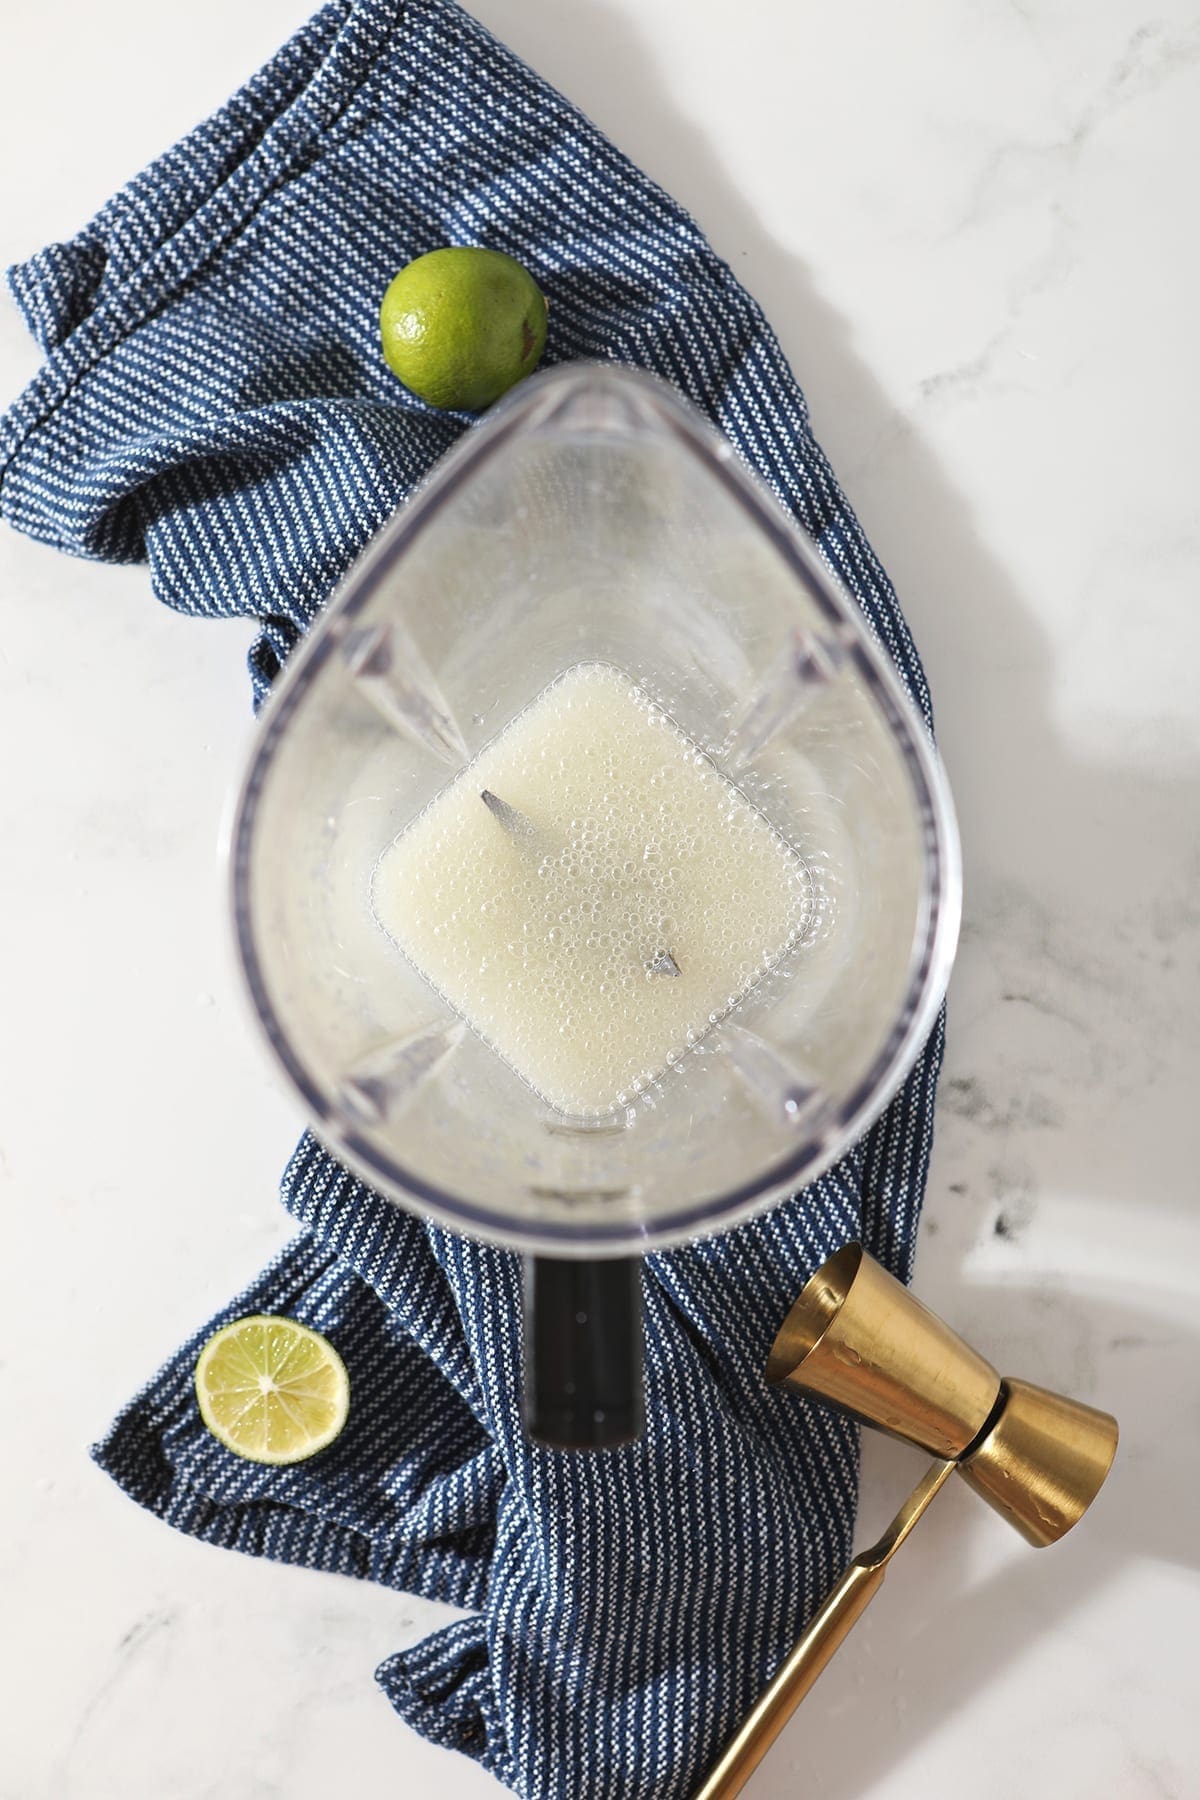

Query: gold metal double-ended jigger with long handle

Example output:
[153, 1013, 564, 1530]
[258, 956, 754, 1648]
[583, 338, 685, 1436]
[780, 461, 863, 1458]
[693, 1244, 1117, 1800]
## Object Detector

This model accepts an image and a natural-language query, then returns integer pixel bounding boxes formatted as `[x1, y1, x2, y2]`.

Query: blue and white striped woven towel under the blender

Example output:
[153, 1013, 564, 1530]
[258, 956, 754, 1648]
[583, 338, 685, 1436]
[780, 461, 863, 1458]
[0, 0, 941, 1800]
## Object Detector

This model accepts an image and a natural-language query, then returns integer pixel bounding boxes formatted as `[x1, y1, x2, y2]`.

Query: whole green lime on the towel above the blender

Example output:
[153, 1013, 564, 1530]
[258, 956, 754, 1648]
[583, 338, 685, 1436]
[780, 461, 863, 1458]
[380, 248, 547, 412]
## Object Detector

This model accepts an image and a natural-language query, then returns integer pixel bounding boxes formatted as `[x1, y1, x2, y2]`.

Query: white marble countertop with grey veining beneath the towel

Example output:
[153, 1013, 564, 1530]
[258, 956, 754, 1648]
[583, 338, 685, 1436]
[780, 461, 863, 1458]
[0, 0, 1200, 1800]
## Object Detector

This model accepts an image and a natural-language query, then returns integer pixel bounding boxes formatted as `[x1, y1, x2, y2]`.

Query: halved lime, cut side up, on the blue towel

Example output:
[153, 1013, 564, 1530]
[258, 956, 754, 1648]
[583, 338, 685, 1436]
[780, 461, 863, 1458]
[196, 1312, 351, 1463]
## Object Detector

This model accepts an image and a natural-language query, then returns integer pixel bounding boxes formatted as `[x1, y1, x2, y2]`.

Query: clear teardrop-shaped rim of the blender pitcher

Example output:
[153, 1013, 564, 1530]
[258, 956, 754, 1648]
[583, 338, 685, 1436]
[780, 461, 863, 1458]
[223, 364, 963, 1258]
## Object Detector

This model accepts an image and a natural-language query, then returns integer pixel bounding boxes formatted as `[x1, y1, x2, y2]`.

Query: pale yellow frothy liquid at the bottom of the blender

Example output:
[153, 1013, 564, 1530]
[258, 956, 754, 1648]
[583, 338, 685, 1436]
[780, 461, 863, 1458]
[372, 662, 811, 1114]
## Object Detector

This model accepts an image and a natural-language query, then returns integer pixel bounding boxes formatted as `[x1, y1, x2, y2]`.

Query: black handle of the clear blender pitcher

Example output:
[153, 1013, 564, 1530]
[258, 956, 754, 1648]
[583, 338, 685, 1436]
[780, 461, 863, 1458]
[525, 1256, 644, 1451]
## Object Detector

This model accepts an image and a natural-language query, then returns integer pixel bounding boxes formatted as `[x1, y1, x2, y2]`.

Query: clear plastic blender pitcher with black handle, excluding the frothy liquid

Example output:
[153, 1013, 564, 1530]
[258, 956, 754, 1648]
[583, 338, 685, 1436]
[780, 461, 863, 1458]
[232, 365, 959, 1447]
